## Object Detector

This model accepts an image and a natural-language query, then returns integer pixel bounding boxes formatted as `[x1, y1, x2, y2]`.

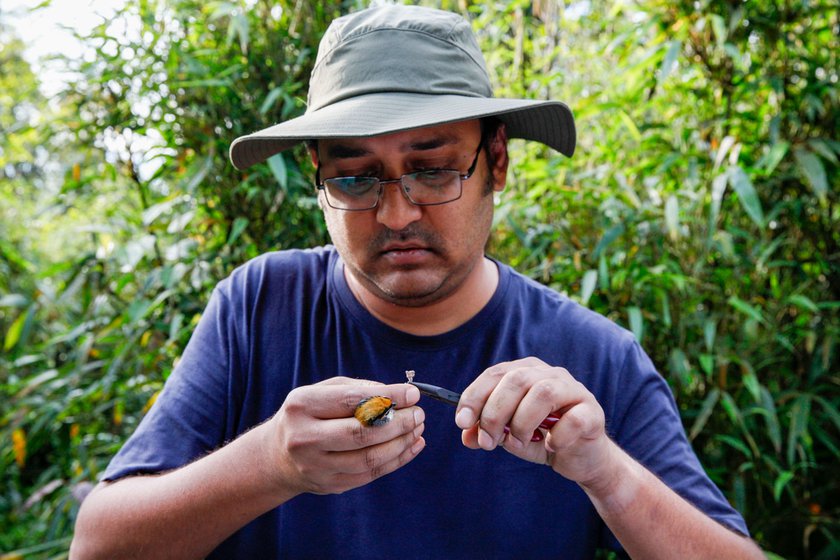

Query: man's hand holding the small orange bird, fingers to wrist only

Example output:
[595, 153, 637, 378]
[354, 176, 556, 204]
[267, 377, 425, 494]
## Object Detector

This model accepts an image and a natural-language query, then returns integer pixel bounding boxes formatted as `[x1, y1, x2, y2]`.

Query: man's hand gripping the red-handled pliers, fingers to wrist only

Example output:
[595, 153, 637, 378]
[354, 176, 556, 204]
[455, 358, 614, 486]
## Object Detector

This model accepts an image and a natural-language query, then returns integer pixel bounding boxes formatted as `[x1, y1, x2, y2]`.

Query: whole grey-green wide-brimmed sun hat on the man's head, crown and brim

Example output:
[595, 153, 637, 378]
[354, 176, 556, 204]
[230, 6, 575, 169]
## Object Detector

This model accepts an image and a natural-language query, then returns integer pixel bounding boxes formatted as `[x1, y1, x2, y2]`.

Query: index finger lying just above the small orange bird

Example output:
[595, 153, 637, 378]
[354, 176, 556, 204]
[295, 377, 420, 419]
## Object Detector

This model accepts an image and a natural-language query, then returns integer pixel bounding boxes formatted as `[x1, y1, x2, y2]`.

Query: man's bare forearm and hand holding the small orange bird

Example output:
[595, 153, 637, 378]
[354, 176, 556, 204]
[70, 378, 425, 560]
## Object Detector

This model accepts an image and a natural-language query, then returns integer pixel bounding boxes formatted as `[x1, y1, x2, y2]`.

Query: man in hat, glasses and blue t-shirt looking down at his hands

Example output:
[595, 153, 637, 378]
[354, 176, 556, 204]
[71, 6, 762, 558]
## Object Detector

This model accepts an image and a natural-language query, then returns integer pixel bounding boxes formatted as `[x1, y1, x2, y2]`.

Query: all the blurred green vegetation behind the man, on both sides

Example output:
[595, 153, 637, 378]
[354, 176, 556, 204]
[0, 0, 840, 559]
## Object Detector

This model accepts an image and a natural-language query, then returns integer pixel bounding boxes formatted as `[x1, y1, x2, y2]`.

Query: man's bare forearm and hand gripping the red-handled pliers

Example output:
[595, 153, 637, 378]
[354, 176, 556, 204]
[455, 358, 763, 559]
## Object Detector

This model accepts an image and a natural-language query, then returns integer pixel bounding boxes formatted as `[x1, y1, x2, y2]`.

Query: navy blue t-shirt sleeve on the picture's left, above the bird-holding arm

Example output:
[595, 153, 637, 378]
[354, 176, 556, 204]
[102, 284, 236, 481]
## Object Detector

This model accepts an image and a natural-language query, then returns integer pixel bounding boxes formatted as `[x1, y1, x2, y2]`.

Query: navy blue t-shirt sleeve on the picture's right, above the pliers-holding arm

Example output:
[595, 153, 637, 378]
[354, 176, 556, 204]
[607, 342, 749, 535]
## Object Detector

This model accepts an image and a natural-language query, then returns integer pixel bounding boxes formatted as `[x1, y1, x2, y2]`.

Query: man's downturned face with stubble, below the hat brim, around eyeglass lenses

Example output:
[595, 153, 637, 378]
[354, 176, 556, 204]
[313, 121, 507, 307]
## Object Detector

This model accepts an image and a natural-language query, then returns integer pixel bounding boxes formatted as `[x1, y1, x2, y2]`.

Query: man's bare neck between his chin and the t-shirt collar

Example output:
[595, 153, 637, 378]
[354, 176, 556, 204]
[344, 257, 499, 336]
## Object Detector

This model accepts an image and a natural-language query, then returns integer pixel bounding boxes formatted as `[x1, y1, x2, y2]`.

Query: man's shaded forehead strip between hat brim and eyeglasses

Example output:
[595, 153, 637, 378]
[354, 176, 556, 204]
[318, 119, 481, 158]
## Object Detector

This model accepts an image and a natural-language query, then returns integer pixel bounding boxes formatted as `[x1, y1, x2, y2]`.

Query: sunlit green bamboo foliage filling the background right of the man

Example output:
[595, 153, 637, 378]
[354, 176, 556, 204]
[477, 2, 840, 558]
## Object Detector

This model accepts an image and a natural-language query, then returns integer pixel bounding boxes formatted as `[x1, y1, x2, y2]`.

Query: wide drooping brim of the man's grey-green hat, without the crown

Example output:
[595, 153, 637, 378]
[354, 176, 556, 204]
[230, 93, 575, 169]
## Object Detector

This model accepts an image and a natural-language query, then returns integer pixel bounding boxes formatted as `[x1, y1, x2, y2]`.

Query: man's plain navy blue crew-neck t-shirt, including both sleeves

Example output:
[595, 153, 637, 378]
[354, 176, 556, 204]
[104, 247, 747, 559]
